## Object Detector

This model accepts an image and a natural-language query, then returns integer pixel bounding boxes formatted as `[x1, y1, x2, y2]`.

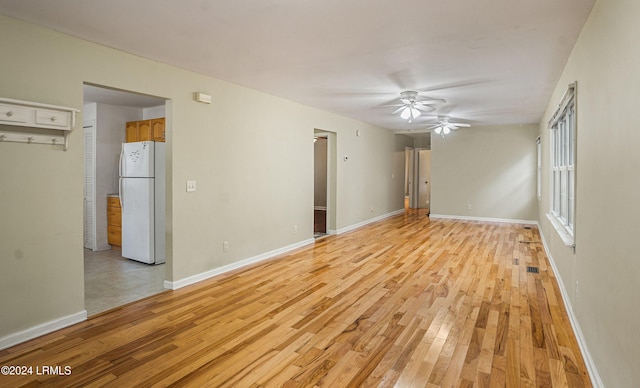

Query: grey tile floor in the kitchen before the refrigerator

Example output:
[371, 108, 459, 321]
[84, 249, 165, 316]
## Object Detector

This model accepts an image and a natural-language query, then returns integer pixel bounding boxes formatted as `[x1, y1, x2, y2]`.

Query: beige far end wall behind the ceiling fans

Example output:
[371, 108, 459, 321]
[431, 125, 538, 221]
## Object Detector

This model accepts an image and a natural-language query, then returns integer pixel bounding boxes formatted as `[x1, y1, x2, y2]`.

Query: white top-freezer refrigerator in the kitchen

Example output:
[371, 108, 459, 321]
[120, 141, 166, 264]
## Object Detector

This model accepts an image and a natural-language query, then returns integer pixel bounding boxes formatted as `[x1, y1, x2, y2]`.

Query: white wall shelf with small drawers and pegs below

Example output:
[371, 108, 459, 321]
[0, 98, 79, 151]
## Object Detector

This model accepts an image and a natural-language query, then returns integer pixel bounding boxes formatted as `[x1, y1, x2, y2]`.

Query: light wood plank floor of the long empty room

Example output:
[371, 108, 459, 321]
[0, 212, 590, 387]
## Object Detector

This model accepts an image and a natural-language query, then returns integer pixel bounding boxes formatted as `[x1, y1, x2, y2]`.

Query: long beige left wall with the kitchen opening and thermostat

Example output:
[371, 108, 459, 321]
[0, 16, 403, 339]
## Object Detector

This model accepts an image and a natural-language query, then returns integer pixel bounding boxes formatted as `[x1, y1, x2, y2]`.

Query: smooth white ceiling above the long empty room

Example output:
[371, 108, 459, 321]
[0, 0, 594, 131]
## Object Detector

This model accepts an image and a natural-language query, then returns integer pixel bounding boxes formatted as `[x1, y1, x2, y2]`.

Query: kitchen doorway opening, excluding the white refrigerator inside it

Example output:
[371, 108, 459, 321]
[82, 84, 166, 316]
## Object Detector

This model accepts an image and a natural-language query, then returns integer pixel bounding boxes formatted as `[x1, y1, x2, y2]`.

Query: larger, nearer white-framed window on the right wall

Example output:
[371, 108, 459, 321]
[549, 83, 576, 245]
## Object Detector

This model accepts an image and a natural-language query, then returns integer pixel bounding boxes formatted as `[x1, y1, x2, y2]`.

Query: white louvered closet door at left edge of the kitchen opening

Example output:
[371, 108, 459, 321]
[82, 122, 97, 251]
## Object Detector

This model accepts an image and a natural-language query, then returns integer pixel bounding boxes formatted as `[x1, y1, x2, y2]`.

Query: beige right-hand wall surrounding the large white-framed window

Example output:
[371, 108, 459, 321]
[540, 0, 640, 387]
